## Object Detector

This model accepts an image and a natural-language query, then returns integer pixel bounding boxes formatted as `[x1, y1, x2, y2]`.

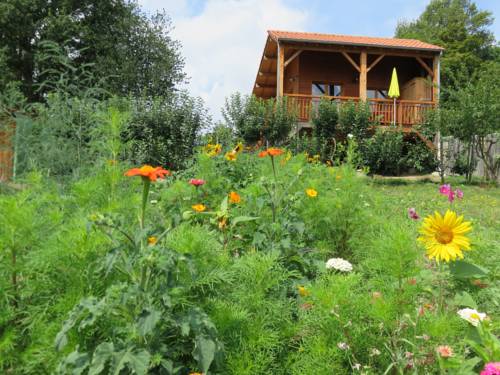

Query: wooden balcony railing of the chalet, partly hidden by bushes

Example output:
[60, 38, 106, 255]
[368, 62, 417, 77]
[285, 94, 435, 126]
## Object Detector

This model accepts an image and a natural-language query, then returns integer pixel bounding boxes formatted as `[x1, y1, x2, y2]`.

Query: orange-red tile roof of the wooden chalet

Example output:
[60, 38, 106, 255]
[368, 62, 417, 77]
[268, 30, 444, 51]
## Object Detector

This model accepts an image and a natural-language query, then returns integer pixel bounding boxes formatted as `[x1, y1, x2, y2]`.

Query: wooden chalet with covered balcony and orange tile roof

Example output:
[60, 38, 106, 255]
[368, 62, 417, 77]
[253, 30, 443, 135]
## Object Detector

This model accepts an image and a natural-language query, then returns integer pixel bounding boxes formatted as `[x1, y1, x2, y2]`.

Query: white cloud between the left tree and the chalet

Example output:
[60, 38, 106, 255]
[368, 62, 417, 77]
[141, 0, 309, 120]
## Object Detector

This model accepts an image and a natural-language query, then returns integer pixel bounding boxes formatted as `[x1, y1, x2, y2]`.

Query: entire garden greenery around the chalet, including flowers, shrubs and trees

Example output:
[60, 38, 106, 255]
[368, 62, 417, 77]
[0, 0, 500, 375]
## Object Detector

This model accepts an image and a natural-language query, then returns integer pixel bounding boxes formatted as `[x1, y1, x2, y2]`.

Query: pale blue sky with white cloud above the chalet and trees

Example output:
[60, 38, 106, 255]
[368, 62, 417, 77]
[138, 0, 500, 121]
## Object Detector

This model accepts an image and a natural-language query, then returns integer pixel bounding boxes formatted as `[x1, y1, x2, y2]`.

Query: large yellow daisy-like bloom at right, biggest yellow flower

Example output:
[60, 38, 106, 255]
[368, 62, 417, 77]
[418, 210, 472, 262]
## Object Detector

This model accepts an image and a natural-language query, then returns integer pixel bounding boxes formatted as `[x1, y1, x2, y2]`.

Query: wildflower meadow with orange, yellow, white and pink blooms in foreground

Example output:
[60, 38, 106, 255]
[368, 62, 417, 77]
[0, 139, 500, 375]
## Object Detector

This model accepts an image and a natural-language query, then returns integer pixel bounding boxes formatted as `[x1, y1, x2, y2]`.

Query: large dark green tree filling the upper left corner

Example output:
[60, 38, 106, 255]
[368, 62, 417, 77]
[0, 0, 184, 101]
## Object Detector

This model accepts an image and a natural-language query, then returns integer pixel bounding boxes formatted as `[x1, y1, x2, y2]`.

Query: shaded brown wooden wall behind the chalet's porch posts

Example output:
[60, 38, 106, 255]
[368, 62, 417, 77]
[292, 51, 426, 97]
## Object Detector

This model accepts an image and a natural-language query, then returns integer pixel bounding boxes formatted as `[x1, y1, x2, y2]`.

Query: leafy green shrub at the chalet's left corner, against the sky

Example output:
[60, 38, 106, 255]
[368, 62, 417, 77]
[222, 93, 297, 145]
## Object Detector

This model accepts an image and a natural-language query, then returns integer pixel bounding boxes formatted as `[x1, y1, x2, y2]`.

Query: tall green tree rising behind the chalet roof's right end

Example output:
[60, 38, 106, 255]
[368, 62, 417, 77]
[395, 0, 498, 87]
